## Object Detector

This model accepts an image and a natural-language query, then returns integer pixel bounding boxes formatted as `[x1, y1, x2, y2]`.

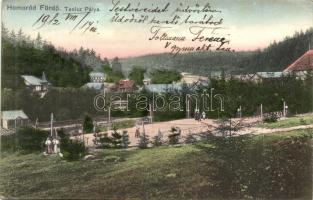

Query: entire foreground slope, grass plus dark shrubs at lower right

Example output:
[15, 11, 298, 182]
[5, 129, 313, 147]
[0, 131, 312, 200]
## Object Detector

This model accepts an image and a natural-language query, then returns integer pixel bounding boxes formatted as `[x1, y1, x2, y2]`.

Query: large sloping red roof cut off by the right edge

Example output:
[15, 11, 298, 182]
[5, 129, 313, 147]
[284, 50, 313, 72]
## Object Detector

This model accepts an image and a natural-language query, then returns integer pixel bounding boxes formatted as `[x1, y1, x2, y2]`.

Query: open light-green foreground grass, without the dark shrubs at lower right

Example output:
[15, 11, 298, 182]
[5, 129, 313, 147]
[0, 131, 311, 199]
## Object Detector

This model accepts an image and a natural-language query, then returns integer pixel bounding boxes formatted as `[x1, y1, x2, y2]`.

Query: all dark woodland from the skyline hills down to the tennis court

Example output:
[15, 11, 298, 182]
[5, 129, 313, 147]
[1, 27, 313, 121]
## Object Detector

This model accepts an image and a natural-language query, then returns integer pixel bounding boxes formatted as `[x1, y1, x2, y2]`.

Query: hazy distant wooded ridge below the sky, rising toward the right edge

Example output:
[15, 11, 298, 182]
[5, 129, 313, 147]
[122, 28, 313, 75]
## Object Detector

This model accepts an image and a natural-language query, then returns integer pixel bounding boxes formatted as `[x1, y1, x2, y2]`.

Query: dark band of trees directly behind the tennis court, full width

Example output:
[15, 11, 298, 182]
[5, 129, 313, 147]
[1, 74, 313, 121]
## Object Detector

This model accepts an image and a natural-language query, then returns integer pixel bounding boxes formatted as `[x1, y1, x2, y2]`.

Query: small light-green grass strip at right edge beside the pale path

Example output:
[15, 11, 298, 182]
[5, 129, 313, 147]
[258, 115, 313, 129]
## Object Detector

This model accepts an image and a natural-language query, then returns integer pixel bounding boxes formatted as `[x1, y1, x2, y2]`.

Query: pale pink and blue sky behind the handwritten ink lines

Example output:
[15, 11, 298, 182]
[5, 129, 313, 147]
[2, 0, 313, 58]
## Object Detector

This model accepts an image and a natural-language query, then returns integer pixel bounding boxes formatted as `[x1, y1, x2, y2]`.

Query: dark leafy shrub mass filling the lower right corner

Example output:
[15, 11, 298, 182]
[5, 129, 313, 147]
[202, 132, 312, 199]
